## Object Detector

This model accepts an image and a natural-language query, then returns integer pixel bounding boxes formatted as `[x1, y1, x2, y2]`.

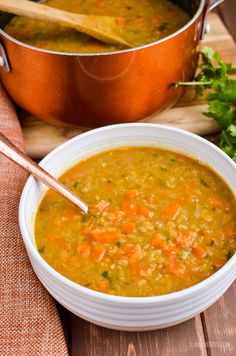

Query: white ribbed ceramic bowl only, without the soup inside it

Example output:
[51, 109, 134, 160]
[19, 124, 236, 331]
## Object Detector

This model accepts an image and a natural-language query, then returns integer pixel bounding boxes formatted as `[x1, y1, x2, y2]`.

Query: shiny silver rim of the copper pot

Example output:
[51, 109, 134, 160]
[0, 0, 206, 57]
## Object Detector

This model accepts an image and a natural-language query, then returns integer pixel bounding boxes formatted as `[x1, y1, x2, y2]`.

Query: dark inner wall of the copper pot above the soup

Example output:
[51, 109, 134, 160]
[0, 0, 203, 29]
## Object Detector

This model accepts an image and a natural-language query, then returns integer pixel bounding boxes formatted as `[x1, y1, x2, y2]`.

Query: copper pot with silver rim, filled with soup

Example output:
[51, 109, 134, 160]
[0, 0, 222, 127]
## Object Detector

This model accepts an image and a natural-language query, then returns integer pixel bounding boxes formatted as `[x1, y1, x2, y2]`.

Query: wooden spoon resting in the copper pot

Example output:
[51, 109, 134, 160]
[0, 0, 133, 48]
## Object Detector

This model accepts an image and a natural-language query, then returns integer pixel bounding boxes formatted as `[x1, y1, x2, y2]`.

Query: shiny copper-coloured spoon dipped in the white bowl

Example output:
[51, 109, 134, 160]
[0, 132, 88, 213]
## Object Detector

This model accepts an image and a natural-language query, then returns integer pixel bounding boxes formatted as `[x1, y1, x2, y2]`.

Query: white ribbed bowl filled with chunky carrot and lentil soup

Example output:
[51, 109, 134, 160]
[19, 123, 236, 331]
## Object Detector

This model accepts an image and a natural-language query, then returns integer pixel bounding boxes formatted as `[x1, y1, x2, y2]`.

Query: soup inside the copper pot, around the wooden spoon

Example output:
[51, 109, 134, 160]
[4, 0, 190, 53]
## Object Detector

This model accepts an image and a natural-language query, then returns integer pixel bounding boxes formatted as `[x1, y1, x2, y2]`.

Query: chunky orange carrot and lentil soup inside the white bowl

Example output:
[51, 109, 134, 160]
[35, 147, 236, 297]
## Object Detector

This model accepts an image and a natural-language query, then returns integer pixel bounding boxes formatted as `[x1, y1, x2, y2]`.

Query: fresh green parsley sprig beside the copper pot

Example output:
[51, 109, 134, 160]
[176, 47, 236, 162]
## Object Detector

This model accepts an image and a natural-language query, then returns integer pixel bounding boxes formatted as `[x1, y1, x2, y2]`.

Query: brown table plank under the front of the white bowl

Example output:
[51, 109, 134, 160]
[70, 314, 207, 356]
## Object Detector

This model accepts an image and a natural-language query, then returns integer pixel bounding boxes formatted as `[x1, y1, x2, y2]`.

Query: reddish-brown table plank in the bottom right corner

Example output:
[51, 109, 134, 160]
[202, 282, 236, 356]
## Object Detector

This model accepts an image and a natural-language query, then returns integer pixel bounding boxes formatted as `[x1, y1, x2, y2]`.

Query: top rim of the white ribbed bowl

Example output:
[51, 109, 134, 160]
[18, 123, 236, 304]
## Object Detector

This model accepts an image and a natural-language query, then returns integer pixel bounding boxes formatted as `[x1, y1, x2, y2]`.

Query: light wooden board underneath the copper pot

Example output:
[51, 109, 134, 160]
[22, 13, 236, 159]
